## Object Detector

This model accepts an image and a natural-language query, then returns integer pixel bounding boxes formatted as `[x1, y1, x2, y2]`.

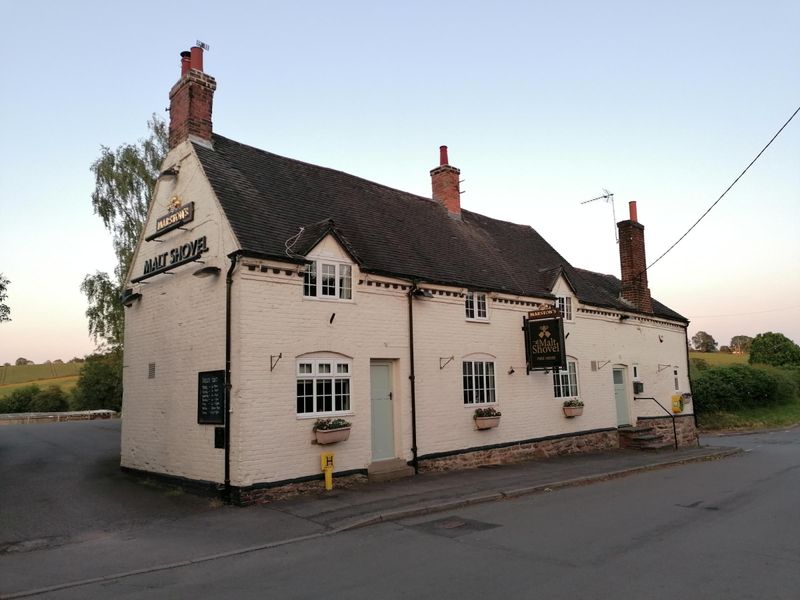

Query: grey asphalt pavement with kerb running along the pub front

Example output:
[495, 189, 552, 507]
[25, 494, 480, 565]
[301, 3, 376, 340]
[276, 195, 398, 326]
[0, 440, 742, 599]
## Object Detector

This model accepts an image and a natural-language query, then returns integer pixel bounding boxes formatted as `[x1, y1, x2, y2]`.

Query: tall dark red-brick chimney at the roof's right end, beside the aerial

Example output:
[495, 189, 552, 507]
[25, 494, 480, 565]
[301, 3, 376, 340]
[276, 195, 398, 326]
[617, 202, 653, 313]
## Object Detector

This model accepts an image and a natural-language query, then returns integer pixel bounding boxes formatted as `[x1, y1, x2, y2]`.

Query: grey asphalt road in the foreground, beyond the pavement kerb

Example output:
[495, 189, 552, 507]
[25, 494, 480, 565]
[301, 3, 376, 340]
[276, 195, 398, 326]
[0, 426, 800, 600]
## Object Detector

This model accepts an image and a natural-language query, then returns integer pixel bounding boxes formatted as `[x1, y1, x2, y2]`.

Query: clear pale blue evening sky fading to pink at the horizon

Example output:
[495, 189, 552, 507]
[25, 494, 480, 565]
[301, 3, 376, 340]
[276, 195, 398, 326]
[0, 0, 800, 364]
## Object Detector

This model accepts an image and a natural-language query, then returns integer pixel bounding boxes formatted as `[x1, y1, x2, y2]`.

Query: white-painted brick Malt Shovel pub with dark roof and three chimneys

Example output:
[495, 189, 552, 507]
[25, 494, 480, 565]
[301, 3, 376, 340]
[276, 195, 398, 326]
[121, 48, 697, 502]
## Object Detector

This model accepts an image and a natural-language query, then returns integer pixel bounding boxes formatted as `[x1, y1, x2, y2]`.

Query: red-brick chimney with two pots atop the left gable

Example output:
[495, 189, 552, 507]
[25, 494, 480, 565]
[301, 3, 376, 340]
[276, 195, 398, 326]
[169, 46, 217, 150]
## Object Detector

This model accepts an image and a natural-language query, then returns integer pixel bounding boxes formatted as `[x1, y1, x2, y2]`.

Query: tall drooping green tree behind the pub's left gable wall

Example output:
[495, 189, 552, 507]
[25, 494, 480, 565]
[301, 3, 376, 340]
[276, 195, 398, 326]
[81, 115, 168, 350]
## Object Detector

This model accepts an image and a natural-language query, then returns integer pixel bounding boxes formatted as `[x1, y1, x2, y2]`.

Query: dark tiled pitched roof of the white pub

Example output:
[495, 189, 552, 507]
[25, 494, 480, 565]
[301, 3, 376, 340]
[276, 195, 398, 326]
[194, 134, 685, 320]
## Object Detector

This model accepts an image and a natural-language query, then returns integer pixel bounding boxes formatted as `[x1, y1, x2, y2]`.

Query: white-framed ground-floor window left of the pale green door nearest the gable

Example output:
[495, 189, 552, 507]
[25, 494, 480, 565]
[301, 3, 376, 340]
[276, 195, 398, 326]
[297, 358, 350, 416]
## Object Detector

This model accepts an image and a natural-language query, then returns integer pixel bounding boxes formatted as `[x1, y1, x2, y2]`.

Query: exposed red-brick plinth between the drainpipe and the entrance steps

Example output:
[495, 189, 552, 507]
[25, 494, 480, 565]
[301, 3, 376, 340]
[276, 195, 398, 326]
[419, 429, 619, 472]
